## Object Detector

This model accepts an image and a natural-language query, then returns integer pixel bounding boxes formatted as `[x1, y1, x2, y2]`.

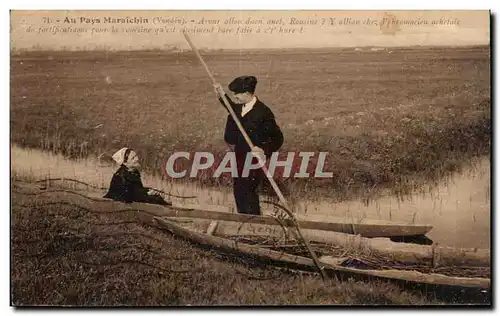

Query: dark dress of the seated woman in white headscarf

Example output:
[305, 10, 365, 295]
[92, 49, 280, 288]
[104, 165, 172, 205]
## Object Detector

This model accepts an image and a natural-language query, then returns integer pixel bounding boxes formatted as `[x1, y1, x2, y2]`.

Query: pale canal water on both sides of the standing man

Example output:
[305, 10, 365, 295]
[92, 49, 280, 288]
[11, 146, 490, 248]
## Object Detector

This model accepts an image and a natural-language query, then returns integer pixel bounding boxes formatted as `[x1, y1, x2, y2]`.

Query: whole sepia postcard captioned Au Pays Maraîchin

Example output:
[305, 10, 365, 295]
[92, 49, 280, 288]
[10, 10, 492, 306]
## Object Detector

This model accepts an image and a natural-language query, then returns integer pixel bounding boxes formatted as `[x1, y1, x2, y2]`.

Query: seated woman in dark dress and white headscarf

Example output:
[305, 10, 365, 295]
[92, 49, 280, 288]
[104, 147, 172, 205]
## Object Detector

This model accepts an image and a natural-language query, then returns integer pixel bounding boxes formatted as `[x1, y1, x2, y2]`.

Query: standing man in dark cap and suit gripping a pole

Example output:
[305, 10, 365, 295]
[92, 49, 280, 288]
[214, 76, 284, 215]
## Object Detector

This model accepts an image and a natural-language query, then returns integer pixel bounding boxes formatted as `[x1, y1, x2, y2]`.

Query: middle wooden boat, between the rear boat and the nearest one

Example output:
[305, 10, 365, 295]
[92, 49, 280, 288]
[163, 216, 490, 268]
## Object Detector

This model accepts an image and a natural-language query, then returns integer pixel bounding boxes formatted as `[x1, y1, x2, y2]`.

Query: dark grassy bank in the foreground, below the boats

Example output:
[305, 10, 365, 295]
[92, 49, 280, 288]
[11, 183, 458, 306]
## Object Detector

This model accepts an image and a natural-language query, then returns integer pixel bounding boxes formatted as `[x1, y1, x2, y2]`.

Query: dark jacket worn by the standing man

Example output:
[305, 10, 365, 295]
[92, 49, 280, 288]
[219, 95, 284, 157]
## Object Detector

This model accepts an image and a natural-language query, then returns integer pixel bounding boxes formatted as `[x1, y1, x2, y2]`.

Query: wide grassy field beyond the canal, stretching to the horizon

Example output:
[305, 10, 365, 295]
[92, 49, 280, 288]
[10, 47, 491, 199]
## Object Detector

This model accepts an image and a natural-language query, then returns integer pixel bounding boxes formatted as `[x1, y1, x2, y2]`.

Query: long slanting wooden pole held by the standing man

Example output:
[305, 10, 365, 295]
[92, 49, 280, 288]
[182, 31, 326, 279]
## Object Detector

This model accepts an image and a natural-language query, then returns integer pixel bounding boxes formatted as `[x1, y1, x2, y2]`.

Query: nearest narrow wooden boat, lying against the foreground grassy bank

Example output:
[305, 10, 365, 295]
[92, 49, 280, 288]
[154, 217, 490, 289]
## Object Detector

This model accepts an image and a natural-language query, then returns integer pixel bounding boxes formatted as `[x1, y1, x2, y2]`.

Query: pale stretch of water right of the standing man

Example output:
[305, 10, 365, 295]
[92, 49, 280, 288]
[292, 158, 490, 248]
